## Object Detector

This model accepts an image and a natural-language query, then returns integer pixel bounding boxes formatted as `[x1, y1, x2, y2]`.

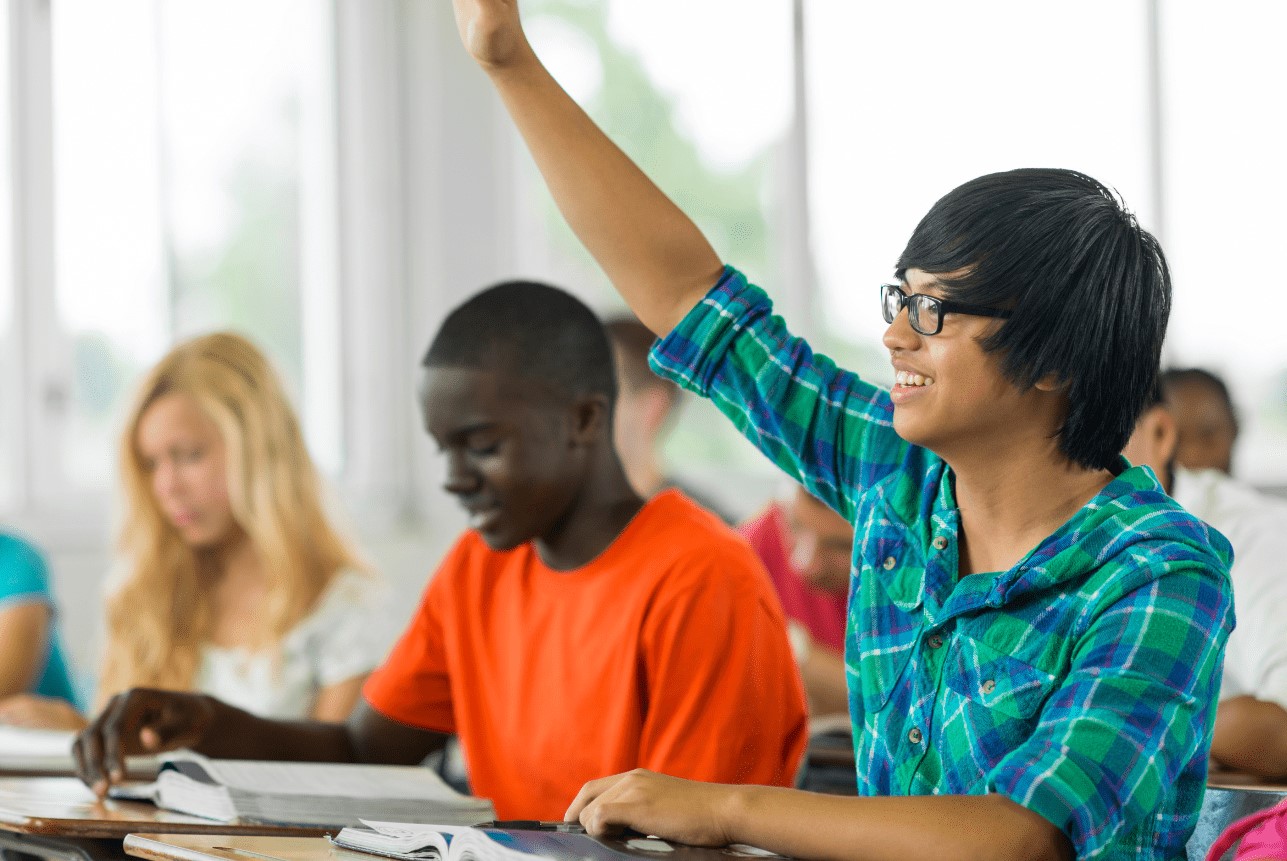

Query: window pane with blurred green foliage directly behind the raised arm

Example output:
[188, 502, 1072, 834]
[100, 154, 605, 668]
[516, 0, 795, 514]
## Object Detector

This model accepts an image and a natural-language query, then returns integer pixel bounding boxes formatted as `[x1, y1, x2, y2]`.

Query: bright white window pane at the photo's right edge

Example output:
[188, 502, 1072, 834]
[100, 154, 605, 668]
[1161, 0, 1287, 485]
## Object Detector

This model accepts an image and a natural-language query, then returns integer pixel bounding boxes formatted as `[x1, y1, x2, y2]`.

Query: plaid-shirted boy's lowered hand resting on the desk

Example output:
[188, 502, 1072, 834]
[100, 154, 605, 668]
[564, 768, 736, 846]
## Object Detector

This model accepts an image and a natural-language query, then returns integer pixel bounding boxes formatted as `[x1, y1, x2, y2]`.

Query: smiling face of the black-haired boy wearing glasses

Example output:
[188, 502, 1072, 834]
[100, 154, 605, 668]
[884, 269, 1064, 462]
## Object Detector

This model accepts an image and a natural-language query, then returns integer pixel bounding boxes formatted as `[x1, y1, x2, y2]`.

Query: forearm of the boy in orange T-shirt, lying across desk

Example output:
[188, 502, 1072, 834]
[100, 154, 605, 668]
[194, 698, 356, 762]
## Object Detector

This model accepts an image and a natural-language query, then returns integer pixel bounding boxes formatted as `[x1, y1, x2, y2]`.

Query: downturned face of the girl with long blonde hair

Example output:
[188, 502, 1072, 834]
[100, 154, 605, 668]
[135, 393, 239, 547]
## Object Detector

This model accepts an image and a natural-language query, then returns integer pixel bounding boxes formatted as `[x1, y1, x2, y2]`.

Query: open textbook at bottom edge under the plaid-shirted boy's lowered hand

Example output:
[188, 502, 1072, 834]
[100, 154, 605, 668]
[331, 820, 782, 861]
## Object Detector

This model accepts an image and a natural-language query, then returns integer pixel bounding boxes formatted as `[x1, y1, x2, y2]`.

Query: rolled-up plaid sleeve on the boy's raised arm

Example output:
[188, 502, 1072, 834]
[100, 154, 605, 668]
[651, 266, 932, 520]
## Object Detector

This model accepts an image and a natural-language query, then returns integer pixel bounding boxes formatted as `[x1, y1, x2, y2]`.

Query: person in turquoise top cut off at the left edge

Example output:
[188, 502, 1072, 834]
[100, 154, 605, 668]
[0, 529, 76, 722]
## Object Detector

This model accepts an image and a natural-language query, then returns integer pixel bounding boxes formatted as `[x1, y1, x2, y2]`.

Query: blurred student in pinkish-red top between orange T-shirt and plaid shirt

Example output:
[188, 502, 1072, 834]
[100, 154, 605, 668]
[739, 485, 853, 718]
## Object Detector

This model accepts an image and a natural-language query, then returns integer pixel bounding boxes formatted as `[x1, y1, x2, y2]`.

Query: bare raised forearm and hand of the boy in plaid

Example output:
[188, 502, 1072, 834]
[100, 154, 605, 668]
[453, 0, 722, 336]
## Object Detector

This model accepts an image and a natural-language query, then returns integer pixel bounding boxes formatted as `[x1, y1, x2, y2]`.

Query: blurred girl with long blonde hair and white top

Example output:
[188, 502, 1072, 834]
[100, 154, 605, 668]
[0, 333, 386, 728]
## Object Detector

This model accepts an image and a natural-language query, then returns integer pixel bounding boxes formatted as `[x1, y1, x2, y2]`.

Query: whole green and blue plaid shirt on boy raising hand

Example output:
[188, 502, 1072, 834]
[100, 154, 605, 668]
[653, 268, 1233, 858]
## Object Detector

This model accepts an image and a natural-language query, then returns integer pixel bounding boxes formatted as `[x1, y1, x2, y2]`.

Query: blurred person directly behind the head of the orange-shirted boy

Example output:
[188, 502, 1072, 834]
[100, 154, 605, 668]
[604, 315, 732, 524]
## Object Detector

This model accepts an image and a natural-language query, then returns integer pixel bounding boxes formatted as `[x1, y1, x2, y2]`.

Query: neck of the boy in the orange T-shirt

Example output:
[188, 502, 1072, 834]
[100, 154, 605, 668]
[535, 445, 644, 571]
